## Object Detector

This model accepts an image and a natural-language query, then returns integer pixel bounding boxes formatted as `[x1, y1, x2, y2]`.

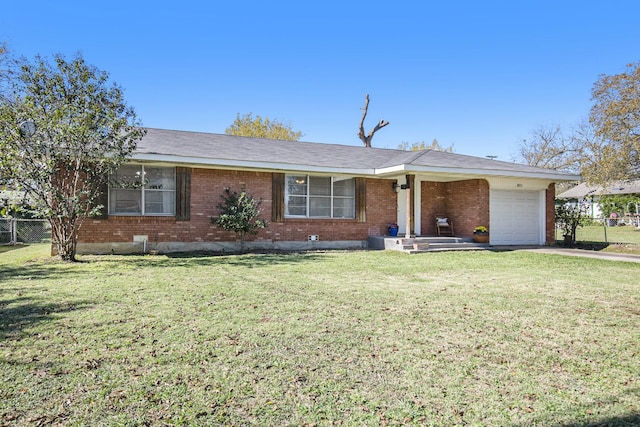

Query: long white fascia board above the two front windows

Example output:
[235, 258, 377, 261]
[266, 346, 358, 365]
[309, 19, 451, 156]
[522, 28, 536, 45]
[131, 154, 375, 176]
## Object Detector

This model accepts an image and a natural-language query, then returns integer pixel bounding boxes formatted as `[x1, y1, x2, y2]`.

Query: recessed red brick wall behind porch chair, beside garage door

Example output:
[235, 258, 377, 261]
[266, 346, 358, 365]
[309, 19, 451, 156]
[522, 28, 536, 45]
[420, 179, 489, 237]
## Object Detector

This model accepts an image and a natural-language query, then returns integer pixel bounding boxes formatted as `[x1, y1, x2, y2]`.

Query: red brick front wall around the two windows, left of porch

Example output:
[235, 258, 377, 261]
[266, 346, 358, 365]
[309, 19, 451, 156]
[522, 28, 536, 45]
[79, 169, 397, 243]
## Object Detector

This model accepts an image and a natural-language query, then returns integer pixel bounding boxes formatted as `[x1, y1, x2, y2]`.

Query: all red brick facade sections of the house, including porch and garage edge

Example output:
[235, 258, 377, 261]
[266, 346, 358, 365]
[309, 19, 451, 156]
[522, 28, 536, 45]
[79, 168, 555, 244]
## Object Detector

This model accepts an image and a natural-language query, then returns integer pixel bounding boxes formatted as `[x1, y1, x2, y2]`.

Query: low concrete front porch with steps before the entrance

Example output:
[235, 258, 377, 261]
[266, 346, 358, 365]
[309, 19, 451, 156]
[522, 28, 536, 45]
[367, 236, 491, 254]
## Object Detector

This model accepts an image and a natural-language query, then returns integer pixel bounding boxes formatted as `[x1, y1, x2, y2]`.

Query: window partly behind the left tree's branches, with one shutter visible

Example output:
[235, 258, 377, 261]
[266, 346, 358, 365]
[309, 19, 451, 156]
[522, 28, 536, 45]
[109, 165, 176, 215]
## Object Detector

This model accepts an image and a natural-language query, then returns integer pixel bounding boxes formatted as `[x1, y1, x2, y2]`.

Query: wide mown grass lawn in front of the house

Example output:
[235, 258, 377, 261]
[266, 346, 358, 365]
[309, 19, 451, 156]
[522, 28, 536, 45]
[0, 245, 640, 427]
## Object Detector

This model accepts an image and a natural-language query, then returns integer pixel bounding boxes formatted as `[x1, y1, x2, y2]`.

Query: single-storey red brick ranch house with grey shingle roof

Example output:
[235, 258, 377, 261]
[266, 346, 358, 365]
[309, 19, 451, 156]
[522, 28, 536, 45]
[78, 129, 580, 253]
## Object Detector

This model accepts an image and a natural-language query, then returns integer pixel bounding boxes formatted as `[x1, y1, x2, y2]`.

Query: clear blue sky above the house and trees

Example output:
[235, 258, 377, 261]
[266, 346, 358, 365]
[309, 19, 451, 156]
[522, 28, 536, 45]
[0, 0, 640, 160]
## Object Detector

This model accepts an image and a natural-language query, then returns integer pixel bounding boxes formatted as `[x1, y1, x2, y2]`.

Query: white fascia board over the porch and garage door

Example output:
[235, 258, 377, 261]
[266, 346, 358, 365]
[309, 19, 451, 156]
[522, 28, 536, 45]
[375, 165, 582, 181]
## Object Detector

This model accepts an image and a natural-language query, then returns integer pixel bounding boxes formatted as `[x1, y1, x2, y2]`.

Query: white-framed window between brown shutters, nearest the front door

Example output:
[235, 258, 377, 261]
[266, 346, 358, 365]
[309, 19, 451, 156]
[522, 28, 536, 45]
[285, 175, 355, 218]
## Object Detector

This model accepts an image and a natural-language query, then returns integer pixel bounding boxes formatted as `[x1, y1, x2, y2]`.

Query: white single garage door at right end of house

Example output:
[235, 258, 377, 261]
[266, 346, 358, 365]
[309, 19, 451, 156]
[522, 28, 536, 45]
[489, 190, 542, 245]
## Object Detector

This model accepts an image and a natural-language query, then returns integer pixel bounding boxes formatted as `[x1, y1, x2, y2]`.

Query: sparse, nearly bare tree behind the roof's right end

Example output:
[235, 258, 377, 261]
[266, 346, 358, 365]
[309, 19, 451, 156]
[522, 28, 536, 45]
[515, 125, 586, 173]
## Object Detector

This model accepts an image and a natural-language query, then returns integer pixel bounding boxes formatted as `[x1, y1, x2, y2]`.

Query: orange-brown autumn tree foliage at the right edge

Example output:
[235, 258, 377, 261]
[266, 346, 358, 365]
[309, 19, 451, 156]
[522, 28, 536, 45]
[584, 63, 640, 183]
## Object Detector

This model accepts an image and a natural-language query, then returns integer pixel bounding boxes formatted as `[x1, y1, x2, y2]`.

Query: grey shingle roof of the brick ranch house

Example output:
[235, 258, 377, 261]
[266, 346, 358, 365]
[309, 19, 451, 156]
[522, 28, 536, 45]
[135, 129, 579, 180]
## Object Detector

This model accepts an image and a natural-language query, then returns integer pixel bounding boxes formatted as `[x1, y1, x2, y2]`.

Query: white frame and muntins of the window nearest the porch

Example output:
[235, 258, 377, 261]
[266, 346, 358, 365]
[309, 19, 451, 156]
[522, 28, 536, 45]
[284, 174, 356, 219]
